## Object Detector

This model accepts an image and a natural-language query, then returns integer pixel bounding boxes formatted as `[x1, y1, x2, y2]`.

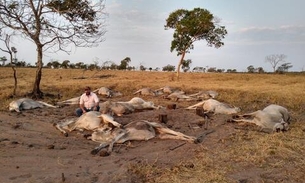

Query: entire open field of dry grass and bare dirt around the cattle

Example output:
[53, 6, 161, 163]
[0, 67, 305, 183]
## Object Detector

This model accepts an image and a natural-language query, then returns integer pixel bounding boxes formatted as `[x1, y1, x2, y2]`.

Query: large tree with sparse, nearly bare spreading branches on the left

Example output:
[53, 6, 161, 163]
[0, 0, 105, 98]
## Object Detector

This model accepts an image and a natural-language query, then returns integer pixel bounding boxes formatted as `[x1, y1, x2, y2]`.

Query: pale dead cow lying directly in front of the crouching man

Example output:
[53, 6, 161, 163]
[54, 111, 121, 136]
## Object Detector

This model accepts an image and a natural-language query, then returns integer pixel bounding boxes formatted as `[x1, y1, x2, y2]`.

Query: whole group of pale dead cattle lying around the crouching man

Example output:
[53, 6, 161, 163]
[9, 86, 290, 154]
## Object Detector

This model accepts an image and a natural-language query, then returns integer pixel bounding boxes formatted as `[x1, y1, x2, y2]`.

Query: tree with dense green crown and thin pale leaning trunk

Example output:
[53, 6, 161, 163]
[164, 8, 227, 78]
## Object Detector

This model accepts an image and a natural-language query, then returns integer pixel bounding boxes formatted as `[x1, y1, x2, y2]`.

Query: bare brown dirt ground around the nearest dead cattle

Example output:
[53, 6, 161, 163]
[0, 96, 288, 183]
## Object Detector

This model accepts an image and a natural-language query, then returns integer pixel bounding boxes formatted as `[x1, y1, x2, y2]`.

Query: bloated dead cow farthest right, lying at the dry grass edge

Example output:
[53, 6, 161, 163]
[231, 104, 290, 132]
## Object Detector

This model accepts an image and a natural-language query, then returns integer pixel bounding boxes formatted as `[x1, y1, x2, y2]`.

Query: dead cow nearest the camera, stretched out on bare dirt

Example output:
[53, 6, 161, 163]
[90, 120, 197, 154]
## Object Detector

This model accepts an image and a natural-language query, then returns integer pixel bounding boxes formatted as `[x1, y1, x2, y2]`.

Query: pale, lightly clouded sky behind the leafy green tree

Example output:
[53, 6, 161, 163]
[10, 0, 305, 71]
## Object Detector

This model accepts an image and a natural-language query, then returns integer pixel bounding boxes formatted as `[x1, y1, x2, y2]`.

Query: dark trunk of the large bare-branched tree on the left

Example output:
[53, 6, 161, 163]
[31, 46, 43, 98]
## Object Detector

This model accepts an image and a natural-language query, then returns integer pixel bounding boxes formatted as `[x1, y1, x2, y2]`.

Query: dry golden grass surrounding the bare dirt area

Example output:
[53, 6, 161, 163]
[0, 68, 305, 183]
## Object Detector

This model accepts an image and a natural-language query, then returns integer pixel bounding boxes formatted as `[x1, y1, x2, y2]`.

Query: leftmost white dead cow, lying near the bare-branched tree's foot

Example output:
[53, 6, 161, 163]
[9, 98, 58, 112]
